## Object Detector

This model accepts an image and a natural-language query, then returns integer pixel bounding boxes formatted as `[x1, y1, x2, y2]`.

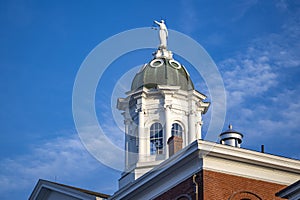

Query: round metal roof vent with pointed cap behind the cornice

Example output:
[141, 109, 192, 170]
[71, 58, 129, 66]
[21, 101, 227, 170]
[219, 124, 243, 147]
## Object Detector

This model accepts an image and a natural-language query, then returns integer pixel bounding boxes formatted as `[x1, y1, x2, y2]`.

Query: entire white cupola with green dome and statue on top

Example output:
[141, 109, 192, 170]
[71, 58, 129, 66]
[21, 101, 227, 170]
[117, 21, 210, 188]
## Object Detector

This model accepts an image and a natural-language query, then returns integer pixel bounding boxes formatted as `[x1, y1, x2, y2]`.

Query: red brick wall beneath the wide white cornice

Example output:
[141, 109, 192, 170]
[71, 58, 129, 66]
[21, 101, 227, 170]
[155, 170, 286, 200]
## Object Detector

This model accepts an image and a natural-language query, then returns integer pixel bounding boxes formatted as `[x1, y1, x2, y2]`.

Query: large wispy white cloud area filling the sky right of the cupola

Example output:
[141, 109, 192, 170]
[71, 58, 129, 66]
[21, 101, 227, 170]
[219, 5, 300, 159]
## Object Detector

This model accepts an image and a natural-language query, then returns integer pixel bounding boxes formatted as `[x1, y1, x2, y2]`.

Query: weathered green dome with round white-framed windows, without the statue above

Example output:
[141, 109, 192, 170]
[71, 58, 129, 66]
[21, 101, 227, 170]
[131, 58, 194, 90]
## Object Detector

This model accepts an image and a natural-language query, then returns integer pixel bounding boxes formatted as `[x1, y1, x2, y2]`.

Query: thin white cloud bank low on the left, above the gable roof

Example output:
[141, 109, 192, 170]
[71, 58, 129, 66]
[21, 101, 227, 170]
[0, 133, 115, 199]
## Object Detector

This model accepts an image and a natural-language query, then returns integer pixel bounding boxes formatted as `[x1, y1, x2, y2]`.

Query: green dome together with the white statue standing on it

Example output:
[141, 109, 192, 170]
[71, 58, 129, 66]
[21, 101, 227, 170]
[131, 20, 194, 91]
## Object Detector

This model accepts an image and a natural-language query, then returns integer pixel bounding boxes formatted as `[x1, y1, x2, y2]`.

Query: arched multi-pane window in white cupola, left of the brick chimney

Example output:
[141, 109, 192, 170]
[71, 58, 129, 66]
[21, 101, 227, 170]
[150, 122, 163, 155]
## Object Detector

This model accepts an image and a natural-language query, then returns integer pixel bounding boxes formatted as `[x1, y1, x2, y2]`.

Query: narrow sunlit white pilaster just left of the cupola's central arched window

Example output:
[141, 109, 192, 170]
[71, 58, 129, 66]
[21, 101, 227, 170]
[139, 109, 147, 161]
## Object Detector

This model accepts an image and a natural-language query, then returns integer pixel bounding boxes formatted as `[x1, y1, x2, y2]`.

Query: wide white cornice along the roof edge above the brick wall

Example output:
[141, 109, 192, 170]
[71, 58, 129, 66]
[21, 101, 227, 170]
[109, 140, 300, 200]
